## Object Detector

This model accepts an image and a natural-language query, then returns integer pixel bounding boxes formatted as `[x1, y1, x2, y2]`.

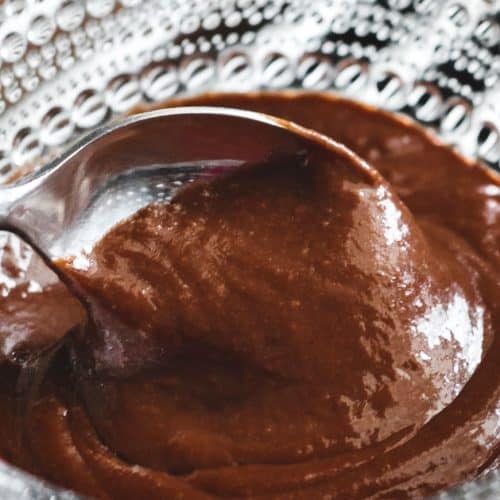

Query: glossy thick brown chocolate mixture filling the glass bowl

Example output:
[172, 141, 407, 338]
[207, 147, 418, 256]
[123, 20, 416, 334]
[0, 94, 500, 499]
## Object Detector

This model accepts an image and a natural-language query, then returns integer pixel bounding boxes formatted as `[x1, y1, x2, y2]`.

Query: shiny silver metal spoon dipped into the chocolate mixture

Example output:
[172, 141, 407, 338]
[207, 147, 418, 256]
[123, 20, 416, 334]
[0, 107, 312, 264]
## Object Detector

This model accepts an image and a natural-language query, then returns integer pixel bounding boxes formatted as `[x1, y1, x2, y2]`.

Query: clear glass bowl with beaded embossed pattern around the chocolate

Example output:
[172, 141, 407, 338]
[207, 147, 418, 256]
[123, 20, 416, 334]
[0, 0, 500, 500]
